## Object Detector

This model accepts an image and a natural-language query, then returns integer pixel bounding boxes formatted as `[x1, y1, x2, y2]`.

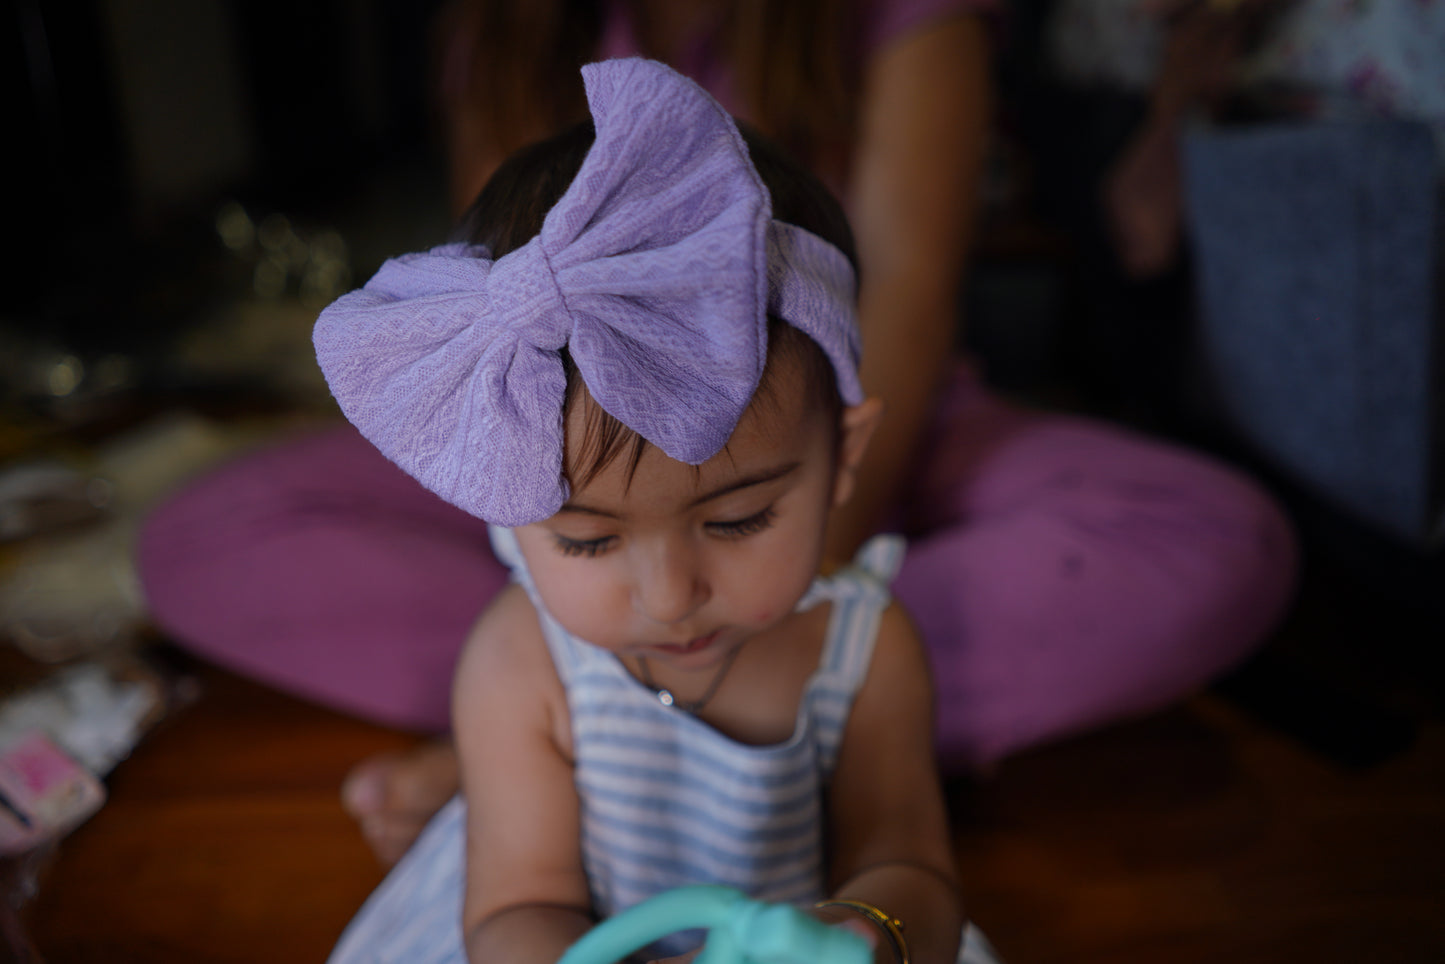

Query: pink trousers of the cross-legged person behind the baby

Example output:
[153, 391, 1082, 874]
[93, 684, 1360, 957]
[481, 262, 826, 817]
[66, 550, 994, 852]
[139, 369, 1296, 767]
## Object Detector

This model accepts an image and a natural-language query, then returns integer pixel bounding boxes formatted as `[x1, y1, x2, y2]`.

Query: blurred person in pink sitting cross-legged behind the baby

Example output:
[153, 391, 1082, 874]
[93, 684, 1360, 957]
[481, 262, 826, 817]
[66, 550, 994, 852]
[140, 0, 1295, 861]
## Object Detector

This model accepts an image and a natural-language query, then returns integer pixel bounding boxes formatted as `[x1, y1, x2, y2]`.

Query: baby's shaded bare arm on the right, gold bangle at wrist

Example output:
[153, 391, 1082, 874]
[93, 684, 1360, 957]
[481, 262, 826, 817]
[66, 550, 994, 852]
[822, 606, 964, 964]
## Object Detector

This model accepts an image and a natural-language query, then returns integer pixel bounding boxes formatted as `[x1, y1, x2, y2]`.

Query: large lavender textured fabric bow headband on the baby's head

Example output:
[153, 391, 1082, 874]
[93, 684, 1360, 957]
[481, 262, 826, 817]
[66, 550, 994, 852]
[315, 59, 863, 526]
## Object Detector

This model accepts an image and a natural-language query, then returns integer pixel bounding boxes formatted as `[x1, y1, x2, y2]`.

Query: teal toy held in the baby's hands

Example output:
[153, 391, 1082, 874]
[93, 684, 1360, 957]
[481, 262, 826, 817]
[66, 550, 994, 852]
[558, 885, 873, 964]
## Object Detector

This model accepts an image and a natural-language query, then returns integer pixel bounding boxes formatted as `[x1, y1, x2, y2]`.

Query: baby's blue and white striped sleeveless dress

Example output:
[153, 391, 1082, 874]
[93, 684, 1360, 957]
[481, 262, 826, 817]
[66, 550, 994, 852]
[331, 529, 988, 964]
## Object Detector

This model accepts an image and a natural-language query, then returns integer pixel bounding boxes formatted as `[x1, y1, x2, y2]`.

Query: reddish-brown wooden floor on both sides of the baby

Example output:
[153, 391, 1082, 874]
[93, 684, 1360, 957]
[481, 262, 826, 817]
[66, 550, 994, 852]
[14, 598, 1445, 964]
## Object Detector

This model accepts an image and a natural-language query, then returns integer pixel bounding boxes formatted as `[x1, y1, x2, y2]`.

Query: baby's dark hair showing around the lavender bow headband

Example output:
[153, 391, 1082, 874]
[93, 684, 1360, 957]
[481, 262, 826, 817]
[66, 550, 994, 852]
[452, 120, 858, 490]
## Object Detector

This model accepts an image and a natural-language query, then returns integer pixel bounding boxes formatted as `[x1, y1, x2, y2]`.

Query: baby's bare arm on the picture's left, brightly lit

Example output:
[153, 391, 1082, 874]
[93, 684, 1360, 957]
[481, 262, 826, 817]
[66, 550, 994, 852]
[452, 587, 592, 964]
